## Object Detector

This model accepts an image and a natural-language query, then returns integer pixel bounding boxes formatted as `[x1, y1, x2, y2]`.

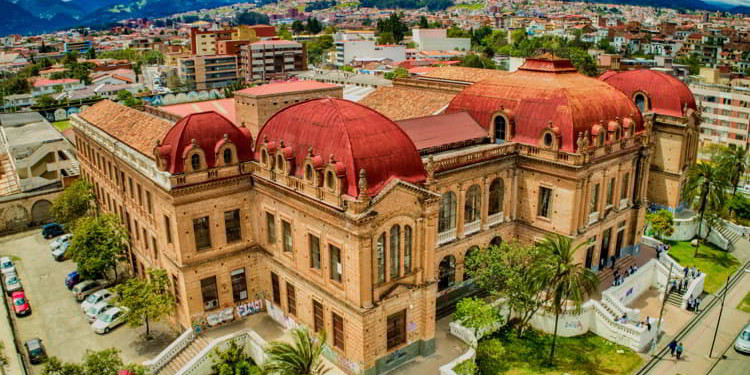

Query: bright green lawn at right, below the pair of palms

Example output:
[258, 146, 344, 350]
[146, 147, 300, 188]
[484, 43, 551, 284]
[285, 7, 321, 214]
[669, 241, 740, 293]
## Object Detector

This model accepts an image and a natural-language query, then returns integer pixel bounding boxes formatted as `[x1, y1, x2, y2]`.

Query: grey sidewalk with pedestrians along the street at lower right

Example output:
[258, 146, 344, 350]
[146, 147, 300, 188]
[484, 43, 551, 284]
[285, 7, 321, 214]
[650, 272, 750, 375]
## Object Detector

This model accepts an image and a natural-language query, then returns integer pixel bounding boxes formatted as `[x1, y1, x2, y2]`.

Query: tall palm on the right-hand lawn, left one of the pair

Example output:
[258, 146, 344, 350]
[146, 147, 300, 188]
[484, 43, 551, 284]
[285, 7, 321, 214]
[682, 162, 729, 256]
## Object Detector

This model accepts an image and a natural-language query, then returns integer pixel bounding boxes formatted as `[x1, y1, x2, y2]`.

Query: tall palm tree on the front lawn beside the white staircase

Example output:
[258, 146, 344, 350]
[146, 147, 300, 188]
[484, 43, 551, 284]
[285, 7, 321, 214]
[537, 234, 599, 361]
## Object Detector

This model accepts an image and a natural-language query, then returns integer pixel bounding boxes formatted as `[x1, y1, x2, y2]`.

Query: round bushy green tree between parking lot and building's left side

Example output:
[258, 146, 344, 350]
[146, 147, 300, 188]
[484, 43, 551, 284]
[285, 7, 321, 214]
[68, 214, 129, 282]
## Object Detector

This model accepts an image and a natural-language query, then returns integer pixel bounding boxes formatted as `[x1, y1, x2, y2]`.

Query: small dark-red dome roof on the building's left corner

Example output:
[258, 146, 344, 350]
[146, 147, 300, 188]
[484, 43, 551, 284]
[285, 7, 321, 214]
[157, 111, 253, 174]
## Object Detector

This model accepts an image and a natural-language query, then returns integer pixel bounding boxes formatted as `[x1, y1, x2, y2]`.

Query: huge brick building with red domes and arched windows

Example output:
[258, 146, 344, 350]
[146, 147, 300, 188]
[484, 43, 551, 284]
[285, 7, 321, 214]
[71, 57, 699, 375]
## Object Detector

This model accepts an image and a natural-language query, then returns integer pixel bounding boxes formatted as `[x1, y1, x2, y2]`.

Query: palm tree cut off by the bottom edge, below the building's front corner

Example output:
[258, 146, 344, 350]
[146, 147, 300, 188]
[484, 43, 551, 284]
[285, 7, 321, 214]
[264, 328, 330, 375]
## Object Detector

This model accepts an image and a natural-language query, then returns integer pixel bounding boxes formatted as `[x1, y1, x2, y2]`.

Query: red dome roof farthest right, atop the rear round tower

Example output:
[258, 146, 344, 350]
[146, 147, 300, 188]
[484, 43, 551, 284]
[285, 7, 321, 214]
[599, 69, 698, 117]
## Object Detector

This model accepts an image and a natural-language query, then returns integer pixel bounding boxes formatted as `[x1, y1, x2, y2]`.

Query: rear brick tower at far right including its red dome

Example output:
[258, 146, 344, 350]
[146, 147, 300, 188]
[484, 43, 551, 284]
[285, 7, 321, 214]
[599, 69, 700, 211]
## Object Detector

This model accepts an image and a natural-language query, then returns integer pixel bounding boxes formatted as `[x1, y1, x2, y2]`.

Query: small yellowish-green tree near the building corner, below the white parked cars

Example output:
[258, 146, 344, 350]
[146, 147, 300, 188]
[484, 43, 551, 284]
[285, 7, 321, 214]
[115, 269, 175, 337]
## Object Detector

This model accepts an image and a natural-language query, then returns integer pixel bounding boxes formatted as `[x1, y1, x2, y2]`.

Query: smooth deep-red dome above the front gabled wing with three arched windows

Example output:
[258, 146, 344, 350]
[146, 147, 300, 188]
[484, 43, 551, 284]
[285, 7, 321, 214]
[256, 98, 426, 197]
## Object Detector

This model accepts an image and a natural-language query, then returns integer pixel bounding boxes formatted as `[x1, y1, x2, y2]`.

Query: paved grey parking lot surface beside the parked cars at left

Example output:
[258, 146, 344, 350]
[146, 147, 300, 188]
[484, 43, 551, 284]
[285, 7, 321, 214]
[0, 230, 176, 374]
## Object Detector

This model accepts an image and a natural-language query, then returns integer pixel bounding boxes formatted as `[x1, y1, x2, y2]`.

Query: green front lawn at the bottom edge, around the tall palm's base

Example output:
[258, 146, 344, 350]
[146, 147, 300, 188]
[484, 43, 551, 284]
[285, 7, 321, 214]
[477, 331, 643, 375]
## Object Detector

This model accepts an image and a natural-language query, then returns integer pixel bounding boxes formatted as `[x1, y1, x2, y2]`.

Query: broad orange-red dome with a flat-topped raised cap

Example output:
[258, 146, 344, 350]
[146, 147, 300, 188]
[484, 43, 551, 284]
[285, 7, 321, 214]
[445, 57, 643, 151]
